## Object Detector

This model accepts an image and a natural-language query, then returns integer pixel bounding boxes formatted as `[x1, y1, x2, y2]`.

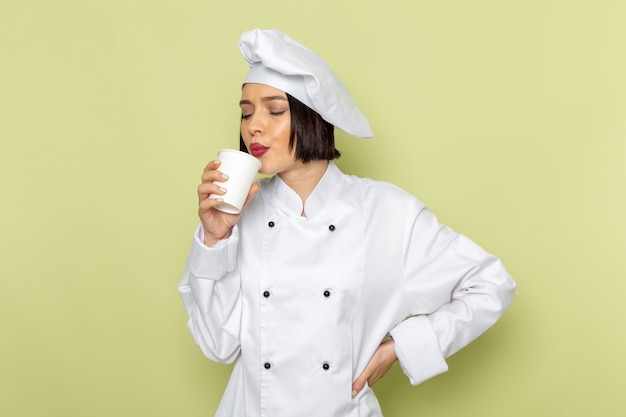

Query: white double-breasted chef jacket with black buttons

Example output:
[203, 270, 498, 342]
[178, 162, 515, 417]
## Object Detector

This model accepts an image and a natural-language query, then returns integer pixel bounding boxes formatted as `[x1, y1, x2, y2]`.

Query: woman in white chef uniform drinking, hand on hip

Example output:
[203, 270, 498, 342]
[178, 29, 515, 417]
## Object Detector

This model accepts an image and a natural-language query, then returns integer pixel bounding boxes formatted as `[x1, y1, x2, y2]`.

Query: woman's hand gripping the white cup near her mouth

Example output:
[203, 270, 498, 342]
[198, 161, 260, 246]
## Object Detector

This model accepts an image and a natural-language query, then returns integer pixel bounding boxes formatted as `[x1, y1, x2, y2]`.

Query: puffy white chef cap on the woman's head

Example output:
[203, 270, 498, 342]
[239, 29, 374, 138]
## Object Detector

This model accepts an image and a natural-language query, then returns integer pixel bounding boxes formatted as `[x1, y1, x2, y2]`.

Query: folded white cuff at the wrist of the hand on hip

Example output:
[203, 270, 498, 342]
[390, 316, 448, 385]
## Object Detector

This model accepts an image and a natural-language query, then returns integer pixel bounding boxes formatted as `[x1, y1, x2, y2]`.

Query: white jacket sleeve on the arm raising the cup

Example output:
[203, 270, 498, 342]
[178, 226, 242, 363]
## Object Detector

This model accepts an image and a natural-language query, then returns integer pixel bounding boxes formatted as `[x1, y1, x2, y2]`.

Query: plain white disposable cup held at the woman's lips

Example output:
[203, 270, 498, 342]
[209, 149, 261, 214]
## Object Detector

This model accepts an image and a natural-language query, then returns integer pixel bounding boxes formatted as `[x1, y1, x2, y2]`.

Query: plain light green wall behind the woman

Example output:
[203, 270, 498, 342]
[0, 0, 626, 417]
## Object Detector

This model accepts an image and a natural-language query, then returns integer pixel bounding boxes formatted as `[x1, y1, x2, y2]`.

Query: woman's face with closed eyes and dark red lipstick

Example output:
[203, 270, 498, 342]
[239, 83, 301, 174]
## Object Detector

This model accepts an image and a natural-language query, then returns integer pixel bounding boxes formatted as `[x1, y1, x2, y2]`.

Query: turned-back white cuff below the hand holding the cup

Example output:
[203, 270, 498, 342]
[187, 225, 239, 280]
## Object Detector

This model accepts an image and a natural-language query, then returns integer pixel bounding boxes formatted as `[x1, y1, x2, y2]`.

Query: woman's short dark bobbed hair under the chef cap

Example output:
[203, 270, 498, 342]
[239, 94, 341, 163]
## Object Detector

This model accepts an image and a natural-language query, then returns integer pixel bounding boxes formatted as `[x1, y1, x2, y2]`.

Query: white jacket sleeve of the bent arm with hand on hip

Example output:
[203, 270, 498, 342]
[391, 209, 516, 385]
